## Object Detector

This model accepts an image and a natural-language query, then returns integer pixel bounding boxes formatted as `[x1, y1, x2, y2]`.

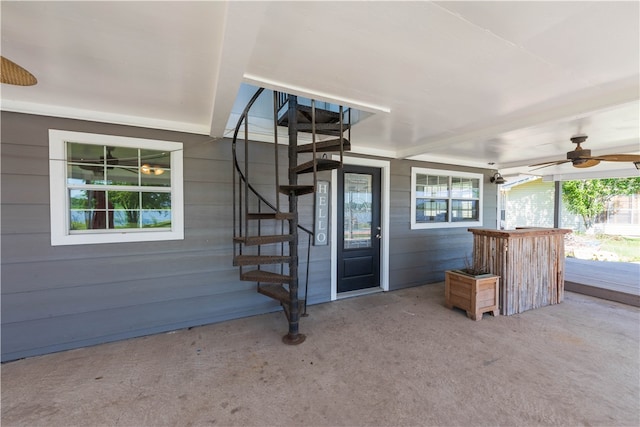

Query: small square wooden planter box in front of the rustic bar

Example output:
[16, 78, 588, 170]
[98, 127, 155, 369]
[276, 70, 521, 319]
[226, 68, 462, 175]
[444, 270, 500, 321]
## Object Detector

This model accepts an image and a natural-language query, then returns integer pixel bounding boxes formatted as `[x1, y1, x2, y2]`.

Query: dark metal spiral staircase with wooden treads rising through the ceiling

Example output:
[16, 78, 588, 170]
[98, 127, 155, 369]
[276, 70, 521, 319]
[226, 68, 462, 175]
[232, 88, 351, 344]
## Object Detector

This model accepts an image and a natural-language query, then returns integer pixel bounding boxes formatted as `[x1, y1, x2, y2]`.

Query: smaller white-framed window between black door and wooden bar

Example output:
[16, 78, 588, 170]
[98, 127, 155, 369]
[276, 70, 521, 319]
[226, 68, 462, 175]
[411, 168, 483, 229]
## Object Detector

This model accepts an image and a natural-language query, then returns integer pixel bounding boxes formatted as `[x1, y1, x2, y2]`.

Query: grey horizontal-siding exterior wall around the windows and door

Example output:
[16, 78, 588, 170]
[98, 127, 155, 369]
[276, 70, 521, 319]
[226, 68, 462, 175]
[1, 112, 497, 361]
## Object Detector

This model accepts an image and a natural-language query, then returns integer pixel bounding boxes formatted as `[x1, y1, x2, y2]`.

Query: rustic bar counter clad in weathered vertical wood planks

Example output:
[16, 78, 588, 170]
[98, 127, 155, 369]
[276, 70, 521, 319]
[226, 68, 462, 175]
[469, 228, 571, 316]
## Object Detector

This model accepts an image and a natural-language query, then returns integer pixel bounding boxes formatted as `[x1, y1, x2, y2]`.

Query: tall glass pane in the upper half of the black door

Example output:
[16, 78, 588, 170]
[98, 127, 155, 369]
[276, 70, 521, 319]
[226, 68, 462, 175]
[344, 173, 372, 249]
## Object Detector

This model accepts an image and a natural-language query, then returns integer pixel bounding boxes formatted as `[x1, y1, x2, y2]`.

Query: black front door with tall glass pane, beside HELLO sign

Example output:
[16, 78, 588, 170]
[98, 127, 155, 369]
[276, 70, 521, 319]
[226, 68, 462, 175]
[337, 165, 382, 293]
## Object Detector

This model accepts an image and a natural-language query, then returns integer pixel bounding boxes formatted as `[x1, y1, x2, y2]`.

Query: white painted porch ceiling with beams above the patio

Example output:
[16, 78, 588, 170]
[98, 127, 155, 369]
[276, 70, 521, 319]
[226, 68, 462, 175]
[0, 1, 640, 178]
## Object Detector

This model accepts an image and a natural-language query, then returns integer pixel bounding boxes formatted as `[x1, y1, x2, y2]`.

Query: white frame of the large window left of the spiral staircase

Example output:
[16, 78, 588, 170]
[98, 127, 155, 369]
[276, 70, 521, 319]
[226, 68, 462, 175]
[49, 129, 184, 246]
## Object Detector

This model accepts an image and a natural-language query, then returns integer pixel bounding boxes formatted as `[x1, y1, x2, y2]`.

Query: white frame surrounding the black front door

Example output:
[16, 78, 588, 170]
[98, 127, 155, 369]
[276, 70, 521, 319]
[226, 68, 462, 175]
[331, 155, 391, 301]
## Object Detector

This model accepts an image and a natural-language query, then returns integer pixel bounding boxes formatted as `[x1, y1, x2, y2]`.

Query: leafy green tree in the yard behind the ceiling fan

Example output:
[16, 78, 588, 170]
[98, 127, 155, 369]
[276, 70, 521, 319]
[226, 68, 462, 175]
[562, 177, 640, 229]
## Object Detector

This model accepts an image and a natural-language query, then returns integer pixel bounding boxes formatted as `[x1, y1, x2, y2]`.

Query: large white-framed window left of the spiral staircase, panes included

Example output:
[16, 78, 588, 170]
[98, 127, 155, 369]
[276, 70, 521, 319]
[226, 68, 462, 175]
[49, 129, 184, 246]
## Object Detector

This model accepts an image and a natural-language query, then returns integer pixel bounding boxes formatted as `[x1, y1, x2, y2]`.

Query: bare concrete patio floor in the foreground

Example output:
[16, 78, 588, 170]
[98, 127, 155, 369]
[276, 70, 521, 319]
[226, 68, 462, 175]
[2, 283, 640, 426]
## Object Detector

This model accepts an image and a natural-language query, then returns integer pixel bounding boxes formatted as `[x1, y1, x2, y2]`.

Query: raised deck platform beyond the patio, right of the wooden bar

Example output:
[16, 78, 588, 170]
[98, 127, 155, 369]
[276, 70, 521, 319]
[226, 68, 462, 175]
[564, 258, 640, 307]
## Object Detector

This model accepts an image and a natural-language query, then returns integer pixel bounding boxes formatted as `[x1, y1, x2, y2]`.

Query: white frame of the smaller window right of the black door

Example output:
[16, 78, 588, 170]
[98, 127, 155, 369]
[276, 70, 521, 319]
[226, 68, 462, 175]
[410, 167, 484, 230]
